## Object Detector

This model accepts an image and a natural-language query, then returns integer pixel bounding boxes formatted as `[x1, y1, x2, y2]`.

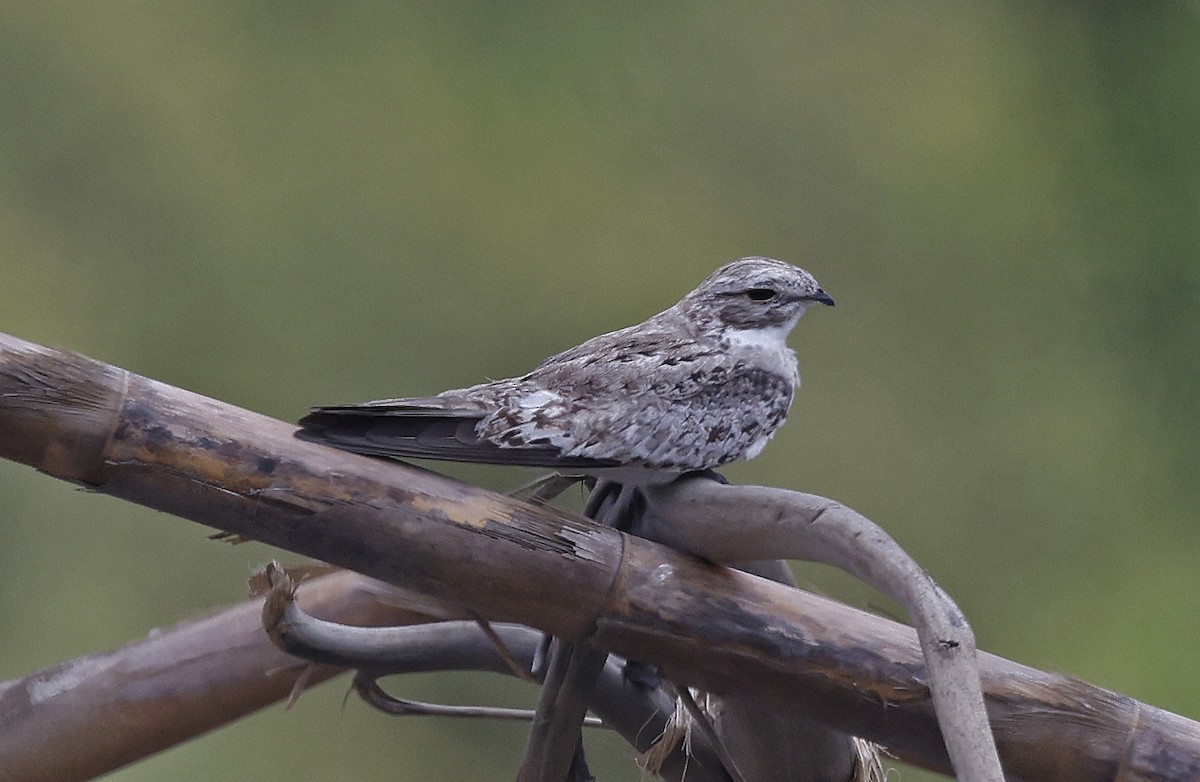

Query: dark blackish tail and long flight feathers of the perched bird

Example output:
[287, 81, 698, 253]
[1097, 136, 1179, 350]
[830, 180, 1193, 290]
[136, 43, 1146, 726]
[296, 396, 617, 470]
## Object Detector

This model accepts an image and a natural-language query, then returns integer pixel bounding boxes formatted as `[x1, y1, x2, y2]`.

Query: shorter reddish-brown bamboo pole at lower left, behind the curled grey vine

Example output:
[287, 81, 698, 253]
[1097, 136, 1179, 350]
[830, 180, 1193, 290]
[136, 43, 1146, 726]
[0, 571, 412, 782]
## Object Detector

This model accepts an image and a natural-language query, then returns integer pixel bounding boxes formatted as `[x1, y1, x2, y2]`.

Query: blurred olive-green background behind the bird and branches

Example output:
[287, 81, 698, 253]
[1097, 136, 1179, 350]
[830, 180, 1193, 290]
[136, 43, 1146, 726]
[0, 1, 1200, 782]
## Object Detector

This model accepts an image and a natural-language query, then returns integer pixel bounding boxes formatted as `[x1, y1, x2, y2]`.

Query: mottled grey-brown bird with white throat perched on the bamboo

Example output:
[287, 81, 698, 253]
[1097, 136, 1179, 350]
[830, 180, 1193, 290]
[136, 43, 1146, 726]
[296, 257, 834, 487]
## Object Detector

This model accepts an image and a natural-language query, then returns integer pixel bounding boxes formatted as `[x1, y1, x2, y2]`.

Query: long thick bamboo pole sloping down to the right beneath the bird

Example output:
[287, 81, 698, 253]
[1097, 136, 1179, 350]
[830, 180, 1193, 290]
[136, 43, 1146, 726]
[0, 337, 1200, 780]
